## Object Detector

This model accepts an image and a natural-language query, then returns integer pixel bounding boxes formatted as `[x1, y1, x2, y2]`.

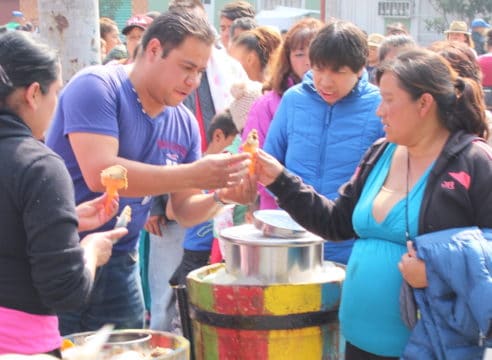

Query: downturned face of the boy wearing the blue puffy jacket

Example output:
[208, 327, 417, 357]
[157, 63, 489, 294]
[312, 65, 364, 105]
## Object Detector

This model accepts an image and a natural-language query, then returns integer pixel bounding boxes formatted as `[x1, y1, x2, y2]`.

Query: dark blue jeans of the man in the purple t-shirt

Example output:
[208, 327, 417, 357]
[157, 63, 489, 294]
[58, 251, 144, 335]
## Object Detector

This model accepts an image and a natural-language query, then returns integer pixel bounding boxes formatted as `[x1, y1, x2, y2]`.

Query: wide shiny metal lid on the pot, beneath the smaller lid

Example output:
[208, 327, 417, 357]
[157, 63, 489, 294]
[220, 224, 323, 247]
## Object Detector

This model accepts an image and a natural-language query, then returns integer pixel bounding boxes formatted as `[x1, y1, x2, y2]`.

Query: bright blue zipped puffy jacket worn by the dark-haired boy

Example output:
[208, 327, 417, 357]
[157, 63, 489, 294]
[264, 71, 384, 263]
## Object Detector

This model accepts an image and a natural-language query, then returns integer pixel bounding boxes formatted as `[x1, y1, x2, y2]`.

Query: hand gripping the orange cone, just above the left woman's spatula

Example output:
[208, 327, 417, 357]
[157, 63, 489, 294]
[75, 193, 119, 231]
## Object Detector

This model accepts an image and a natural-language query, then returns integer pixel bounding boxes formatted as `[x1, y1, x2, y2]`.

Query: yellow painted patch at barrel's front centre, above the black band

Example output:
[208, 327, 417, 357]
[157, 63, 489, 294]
[264, 284, 321, 315]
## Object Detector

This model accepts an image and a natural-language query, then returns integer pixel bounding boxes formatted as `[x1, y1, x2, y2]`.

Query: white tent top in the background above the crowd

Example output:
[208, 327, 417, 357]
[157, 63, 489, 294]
[256, 6, 320, 30]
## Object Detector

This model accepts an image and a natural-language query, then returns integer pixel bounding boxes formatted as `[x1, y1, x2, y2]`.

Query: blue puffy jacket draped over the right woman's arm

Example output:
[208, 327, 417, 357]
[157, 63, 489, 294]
[403, 227, 492, 360]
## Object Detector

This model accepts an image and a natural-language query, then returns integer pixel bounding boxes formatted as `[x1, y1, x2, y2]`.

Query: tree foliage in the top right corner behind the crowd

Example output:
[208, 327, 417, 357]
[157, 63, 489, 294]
[425, 0, 492, 32]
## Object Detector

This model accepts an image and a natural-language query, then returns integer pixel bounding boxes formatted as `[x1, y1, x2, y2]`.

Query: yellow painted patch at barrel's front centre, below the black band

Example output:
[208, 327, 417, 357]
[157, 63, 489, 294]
[268, 327, 323, 360]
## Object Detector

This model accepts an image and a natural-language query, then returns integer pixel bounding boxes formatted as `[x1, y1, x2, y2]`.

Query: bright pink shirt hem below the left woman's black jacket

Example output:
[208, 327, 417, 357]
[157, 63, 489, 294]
[0, 306, 62, 355]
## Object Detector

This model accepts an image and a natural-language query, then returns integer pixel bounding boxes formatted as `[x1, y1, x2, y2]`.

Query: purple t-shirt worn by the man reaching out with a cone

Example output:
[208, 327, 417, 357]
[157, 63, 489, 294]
[46, 65, 201, 252]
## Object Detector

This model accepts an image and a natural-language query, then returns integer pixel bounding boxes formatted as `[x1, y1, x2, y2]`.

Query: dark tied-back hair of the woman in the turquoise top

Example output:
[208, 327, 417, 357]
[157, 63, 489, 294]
[376, 49, 488, 139]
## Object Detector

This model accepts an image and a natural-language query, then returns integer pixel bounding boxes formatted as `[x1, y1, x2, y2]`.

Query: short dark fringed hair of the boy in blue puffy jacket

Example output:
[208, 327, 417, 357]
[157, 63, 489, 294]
[309, 20, 369, 72]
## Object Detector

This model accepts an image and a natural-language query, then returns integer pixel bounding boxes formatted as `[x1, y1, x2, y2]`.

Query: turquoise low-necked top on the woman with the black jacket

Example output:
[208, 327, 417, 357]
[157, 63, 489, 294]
[340, 144, 432, 357]
